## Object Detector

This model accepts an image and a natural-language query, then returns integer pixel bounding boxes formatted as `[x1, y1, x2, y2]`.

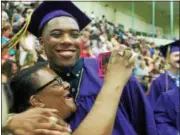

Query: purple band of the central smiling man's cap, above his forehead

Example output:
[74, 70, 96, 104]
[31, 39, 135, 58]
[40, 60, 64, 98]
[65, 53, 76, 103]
[39, 10, 76, 30]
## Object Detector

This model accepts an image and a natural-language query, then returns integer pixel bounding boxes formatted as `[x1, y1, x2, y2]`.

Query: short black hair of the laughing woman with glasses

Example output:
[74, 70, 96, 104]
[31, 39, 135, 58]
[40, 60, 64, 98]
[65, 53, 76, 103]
[9, 62, 48, 113]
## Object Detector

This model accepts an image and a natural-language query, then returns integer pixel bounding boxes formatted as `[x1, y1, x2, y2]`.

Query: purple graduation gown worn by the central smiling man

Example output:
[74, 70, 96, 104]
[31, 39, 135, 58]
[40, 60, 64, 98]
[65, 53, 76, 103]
[70, 58, 157, 135]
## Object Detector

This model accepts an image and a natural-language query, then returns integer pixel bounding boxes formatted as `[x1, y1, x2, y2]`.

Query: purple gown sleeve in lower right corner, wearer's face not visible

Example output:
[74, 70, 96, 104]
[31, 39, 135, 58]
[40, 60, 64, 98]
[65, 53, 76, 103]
[154, 89, 180, 135]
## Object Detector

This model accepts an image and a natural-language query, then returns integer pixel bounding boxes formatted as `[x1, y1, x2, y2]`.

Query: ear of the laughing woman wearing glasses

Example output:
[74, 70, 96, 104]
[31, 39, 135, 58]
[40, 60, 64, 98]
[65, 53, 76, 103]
[29, 95, 45, 107]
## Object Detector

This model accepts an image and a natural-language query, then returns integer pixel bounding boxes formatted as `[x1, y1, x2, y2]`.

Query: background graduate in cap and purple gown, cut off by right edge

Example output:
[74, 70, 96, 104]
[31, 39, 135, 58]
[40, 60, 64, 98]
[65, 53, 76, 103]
[148, 40, 180, 109]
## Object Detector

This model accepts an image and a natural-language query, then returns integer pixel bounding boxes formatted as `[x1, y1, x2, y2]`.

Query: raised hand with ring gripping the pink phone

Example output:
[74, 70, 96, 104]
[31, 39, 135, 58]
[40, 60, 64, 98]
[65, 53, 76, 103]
[105, 45, 137, 85]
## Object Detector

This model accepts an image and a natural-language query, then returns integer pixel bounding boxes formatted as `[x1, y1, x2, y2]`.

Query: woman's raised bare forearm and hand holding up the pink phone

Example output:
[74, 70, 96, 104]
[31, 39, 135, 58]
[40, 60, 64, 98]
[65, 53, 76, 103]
[73, 47, 135, 135]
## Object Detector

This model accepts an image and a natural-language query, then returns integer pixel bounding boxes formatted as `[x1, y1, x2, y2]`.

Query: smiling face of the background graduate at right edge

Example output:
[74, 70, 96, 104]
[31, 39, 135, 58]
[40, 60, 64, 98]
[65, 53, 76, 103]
[169, 51, 180, 68]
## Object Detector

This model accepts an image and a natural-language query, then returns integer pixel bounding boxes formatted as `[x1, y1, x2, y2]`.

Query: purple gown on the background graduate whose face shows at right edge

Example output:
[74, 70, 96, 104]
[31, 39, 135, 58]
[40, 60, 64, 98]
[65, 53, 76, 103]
[148, 72, 177, 109]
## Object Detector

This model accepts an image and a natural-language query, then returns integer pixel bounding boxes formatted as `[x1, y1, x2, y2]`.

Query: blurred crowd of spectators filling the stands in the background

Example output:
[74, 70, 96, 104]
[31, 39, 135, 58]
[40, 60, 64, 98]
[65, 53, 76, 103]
[1, 2, 165, 93]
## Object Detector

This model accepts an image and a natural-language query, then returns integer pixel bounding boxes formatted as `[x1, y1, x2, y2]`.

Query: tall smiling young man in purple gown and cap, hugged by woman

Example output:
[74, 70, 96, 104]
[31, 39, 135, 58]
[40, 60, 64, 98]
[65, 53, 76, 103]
[3, 1, 156, 135]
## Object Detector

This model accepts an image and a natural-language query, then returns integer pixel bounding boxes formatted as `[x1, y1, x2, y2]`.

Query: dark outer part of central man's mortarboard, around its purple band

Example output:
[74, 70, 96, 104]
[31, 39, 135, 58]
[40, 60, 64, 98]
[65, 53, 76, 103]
[28, 1, 91, 37]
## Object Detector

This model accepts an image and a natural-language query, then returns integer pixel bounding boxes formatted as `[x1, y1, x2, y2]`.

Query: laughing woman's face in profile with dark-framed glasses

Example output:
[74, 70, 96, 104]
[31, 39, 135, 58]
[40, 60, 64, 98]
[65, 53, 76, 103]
[30, 67, 76, 119]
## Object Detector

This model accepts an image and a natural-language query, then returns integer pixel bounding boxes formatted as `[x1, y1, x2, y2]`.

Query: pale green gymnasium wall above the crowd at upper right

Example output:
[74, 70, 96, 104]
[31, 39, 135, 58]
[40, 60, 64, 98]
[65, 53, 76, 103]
[74, 1, 179, 38]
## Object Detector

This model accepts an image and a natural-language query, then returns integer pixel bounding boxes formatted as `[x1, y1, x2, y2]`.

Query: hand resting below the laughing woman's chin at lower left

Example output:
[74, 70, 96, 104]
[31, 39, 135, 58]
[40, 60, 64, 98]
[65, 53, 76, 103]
[7, 108, 71, 135]
